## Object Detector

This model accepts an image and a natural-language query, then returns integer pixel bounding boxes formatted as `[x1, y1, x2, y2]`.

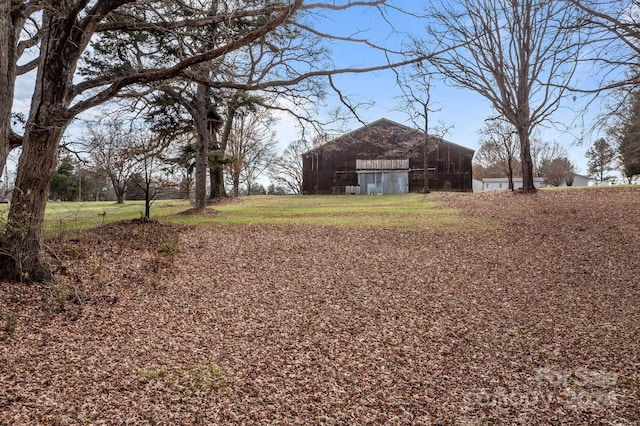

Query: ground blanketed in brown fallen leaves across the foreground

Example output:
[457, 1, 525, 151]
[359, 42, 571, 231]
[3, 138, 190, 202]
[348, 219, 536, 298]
[0, 188, 640, 425]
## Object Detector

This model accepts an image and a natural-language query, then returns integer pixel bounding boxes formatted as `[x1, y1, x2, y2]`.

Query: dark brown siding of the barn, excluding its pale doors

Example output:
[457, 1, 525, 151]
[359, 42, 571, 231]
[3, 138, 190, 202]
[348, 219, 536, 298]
[302, 119, 473, 194]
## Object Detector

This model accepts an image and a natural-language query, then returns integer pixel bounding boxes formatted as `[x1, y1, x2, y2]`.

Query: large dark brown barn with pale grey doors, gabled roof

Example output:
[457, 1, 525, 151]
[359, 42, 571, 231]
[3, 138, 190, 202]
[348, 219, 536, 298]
[302, 118, 474, 195]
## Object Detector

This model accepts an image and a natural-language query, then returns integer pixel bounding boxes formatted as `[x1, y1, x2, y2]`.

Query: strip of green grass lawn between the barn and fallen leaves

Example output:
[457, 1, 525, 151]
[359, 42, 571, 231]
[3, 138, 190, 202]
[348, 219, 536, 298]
[0, 194, 482, 233]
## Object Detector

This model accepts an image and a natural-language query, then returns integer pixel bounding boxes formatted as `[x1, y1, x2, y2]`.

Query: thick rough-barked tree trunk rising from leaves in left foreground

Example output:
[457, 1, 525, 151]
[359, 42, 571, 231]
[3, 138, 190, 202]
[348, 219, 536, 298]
[0, 4, 79, 281]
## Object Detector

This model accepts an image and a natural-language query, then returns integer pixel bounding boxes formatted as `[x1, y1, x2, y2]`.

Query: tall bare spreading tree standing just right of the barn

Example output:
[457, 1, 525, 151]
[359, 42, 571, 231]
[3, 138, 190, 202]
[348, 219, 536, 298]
[422, 0, 581, 192]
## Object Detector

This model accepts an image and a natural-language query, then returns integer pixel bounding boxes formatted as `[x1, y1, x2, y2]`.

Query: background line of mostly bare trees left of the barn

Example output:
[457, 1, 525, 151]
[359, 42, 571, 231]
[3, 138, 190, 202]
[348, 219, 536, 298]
[41, 116, 309, 205]
